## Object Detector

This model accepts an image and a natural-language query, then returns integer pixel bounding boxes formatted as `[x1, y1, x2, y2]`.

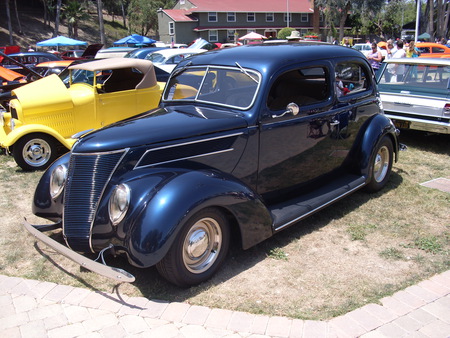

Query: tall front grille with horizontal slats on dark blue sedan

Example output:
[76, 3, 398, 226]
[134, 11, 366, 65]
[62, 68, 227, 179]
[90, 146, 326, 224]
[63, 150, 125, 252]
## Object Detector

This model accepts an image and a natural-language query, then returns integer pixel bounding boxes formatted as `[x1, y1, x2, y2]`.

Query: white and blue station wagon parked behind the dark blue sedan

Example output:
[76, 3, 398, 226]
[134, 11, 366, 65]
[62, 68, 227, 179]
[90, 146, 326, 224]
[378, 58, 450, 134]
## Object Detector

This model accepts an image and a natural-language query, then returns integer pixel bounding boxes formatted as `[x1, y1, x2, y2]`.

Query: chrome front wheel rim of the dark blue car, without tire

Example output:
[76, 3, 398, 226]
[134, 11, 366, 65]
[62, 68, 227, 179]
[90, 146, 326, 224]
[183, 218, 222, 274]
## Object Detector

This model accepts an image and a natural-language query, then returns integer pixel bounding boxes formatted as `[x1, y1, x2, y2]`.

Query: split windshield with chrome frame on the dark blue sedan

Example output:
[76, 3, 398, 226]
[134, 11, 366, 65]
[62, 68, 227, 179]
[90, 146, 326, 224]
[163, 67, 261, 110]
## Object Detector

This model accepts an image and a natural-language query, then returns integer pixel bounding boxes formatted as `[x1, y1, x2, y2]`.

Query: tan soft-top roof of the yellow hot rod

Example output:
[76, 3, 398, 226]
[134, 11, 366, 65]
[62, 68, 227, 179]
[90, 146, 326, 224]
[69, 58, 157, 89]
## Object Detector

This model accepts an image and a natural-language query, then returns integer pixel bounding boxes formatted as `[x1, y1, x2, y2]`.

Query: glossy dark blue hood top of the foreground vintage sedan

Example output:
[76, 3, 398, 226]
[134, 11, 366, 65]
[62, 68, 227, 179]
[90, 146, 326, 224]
[72, 106, 248, 153]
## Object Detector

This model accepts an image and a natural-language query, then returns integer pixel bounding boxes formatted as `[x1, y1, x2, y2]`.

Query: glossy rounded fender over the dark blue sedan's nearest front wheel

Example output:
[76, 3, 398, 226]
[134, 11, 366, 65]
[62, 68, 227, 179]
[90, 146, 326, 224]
[114, 170, 272, 267]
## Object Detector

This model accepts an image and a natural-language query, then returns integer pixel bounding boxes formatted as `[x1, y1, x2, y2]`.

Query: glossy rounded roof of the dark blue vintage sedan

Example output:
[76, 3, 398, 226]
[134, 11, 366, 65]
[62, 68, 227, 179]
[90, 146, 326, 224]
[178, 41, 367, 73]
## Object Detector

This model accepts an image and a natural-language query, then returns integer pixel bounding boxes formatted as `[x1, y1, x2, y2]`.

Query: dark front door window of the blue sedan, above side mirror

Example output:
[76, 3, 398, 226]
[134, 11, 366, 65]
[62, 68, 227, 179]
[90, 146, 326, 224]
[267, 67, 330, 110]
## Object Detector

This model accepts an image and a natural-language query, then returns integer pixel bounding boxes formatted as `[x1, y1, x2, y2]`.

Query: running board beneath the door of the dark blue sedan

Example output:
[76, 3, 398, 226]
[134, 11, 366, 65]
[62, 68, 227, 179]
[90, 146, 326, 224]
[270, 175, 366, 232]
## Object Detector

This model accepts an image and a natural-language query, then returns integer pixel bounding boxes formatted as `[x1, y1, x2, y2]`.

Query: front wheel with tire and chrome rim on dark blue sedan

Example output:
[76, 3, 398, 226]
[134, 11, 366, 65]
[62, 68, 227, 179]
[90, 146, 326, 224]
[156, 208, 230, 287]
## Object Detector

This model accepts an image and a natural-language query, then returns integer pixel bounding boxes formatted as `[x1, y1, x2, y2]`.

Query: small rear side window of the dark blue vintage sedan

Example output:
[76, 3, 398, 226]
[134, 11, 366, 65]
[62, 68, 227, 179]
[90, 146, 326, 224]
[335, 61, 370, 97]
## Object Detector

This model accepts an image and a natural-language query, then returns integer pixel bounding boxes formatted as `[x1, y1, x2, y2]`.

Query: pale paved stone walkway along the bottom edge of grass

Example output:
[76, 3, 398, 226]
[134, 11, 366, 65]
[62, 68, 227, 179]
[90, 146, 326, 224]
[0, 271, 450, 338]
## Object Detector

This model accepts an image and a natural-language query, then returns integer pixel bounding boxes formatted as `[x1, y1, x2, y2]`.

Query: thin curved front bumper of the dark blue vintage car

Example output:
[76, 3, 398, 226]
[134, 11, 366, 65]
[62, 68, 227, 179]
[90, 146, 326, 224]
[23, 219, 135, 283]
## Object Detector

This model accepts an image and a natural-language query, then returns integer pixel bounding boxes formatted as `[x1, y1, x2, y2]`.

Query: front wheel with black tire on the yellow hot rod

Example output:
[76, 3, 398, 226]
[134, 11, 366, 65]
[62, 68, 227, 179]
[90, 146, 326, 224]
[12, 134, 58, 171]
